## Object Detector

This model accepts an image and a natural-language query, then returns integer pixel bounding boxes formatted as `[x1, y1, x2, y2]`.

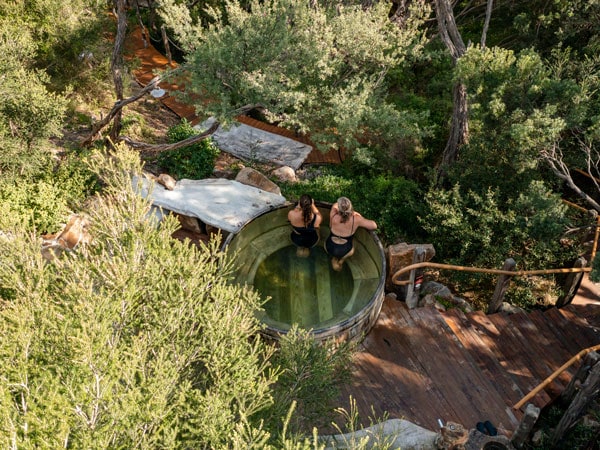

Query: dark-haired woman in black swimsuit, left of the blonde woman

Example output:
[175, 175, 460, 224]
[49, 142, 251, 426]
[288, 194, 323, 258]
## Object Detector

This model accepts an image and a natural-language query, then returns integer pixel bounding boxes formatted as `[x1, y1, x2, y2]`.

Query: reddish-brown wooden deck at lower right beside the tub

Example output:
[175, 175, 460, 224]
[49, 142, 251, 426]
[340, 288, 600, 437]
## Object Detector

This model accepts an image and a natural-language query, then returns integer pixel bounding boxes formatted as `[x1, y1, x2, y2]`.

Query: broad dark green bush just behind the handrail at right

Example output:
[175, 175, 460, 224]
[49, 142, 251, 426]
[420, 182, 577, 302]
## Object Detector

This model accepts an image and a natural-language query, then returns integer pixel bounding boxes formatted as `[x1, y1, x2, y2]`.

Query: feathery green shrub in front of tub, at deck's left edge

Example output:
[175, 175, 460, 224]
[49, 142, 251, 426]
[267, 327, 353, 434]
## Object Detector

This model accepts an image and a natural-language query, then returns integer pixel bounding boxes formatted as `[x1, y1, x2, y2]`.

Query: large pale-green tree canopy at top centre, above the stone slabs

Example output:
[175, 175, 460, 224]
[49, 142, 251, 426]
[179, 0, 432, 155]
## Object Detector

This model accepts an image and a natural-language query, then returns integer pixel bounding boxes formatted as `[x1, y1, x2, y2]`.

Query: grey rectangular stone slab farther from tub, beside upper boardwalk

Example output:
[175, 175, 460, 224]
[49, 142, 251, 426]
[195, 118, 312, 170]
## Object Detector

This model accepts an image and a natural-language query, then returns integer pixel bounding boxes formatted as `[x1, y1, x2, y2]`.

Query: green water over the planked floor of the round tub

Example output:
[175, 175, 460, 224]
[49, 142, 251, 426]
[254, 246, 358, 329]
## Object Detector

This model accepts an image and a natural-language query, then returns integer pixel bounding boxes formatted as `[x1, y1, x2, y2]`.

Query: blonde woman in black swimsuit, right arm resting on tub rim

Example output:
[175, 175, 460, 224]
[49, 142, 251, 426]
[325, 197, 377, 272]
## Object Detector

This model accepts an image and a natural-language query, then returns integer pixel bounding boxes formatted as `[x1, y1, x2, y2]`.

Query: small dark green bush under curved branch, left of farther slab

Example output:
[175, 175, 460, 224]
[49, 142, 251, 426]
[157, 119, 220, 180]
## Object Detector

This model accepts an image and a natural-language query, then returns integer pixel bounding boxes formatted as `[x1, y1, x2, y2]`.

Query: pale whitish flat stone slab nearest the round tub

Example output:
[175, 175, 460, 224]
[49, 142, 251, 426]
[133, 178, 286, 233]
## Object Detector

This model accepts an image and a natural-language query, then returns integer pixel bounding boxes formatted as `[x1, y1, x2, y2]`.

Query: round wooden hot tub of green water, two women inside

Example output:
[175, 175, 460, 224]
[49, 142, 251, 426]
[224, 203, 386, 341]
